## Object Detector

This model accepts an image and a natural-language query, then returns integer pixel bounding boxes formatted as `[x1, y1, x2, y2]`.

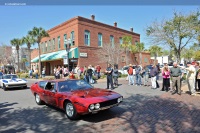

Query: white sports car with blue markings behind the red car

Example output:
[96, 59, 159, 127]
[0, 74, 27, 91]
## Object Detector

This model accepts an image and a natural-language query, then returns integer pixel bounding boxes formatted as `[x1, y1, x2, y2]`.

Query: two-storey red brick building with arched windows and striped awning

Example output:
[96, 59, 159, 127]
[31, 15, 150, 75]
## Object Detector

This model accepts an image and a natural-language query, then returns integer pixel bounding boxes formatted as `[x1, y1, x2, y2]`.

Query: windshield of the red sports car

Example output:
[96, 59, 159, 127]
[58, 80, 93, 92]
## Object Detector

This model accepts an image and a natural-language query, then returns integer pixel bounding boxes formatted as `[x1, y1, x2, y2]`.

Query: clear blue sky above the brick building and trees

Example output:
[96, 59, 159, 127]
[0, 5, 200, 48]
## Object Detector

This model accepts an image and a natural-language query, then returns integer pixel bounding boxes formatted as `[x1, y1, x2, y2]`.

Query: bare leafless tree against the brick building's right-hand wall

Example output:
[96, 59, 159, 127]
[98, 44, 123, 65]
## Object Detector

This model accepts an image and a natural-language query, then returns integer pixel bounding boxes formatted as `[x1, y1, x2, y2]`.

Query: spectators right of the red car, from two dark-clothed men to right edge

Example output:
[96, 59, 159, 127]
[105, 61, 200, 95]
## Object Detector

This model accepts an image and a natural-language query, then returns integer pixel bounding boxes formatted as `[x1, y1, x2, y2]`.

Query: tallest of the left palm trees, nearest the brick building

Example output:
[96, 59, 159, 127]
[28, 27, 49, 77]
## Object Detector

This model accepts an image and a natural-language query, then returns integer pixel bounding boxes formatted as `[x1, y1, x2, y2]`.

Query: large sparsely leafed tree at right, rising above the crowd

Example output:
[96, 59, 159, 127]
[146, 11, 200, 63]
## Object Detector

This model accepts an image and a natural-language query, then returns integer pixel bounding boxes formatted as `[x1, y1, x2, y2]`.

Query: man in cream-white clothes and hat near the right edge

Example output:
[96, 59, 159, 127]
[185, 62, 196, 95]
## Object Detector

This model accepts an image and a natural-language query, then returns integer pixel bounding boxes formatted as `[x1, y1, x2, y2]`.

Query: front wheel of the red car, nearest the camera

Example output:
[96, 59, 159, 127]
[65, 101, 80, 120]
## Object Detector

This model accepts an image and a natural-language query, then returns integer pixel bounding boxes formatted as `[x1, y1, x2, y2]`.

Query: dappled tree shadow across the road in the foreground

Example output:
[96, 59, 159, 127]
[0, 95, 200, 133]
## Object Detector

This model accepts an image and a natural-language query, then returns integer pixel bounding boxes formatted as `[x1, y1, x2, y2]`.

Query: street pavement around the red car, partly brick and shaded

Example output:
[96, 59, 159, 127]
[0, 79, 200, 133]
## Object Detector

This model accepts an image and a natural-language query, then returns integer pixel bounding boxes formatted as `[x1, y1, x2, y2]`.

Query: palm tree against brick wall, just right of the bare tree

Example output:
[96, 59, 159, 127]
[121, 36, 132, 65]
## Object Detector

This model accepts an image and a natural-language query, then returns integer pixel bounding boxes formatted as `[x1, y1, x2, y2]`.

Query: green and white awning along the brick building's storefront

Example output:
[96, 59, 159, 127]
[31, 47, 79, 62]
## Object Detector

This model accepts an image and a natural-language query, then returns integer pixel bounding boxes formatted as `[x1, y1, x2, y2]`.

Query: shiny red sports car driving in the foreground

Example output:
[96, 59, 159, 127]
[31, 79, 123, 119]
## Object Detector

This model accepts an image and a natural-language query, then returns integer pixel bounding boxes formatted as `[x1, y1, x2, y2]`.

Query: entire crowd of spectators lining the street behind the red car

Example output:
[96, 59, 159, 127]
[29, 61, 200, 95]
